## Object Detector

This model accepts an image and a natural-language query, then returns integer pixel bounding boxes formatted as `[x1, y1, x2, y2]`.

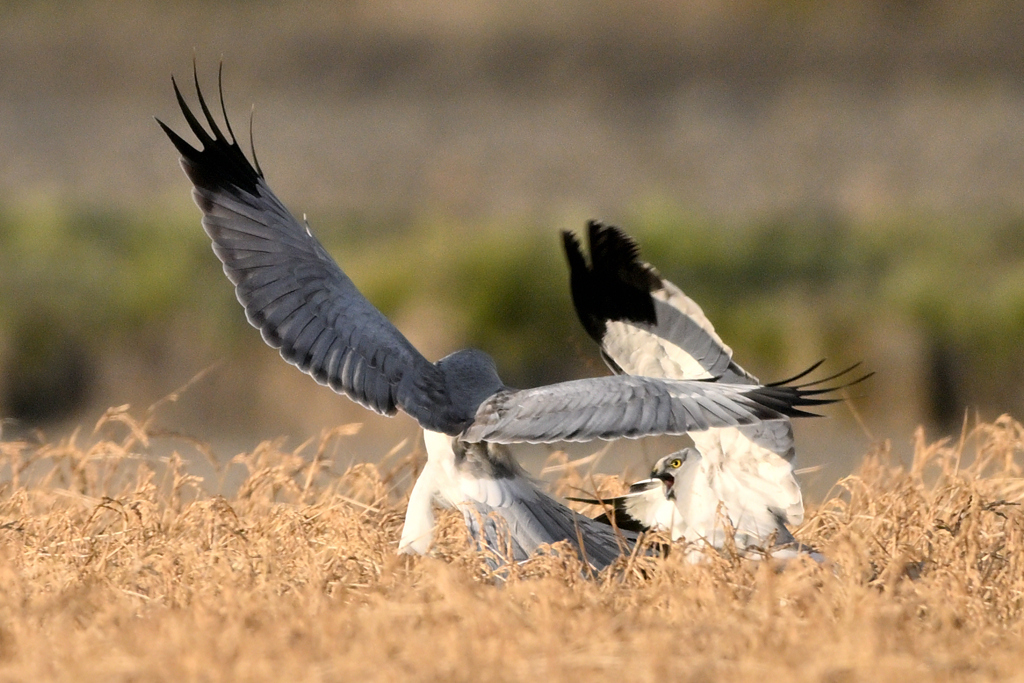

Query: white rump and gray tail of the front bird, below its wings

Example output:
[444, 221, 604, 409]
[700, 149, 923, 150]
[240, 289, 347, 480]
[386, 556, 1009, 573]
[398, 431, 636, 569]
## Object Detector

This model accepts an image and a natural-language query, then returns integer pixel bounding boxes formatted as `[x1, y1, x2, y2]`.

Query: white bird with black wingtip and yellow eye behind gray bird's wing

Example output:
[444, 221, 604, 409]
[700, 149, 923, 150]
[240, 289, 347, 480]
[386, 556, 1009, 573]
[563, 221, 864, 547]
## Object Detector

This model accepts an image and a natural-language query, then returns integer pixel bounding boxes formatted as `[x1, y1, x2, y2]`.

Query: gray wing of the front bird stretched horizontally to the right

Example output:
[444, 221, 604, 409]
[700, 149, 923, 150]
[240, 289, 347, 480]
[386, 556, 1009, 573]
[460, 375, 833, 443]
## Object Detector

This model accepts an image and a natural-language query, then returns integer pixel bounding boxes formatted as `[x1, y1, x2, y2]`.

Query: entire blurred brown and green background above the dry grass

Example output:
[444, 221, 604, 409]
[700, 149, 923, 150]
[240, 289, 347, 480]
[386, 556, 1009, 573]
[0, 0, 1024, 491]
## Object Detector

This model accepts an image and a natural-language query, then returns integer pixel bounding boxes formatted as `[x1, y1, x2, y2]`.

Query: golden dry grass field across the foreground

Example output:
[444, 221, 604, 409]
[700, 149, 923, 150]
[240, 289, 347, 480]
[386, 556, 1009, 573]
[0, 401, 1024, 683]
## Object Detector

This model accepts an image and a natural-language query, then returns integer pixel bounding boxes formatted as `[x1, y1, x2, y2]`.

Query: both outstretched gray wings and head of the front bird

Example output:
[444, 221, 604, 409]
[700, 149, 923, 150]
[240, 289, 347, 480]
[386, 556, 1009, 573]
[159, 69, 829, 443]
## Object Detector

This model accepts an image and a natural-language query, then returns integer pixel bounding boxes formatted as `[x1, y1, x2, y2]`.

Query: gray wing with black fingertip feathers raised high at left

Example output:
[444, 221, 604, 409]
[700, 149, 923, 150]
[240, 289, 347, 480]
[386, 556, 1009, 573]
[158, 68, 466, 433]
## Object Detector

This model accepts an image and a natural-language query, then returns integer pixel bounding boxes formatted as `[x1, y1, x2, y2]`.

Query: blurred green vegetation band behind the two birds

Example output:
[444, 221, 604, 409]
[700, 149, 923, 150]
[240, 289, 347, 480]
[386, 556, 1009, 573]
[0, 202, 1024, 432]
